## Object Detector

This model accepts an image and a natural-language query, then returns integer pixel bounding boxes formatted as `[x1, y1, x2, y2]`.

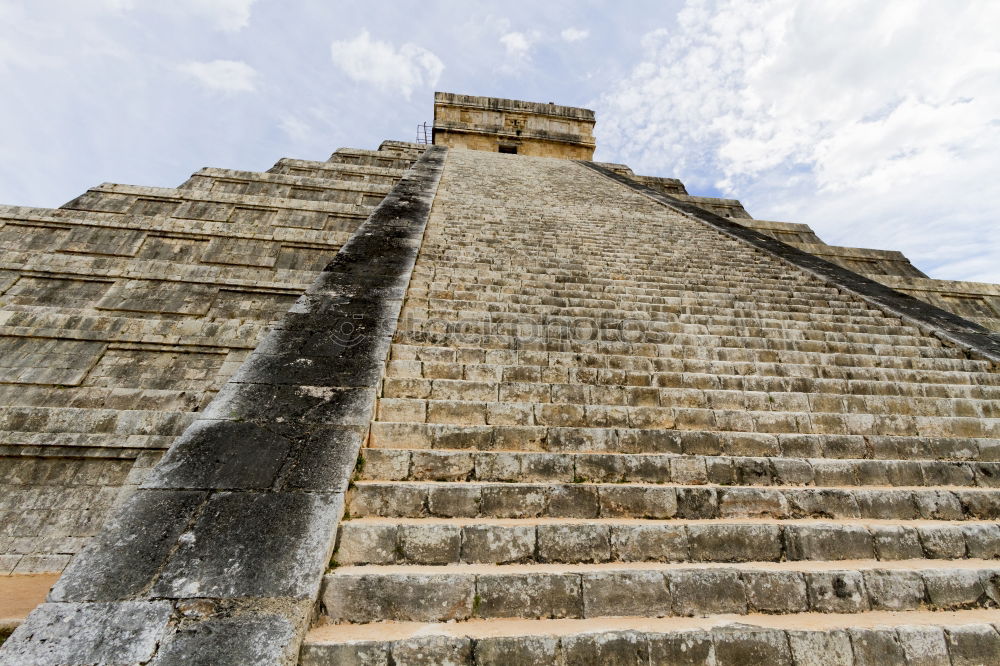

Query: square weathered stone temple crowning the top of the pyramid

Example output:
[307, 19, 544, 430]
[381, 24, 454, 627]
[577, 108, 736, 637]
[434, 92, 596, 160]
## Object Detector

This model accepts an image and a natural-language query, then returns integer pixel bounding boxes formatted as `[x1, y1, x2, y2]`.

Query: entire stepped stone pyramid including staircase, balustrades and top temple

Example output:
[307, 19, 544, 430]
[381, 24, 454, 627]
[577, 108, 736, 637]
[0, 93, 1000, 666]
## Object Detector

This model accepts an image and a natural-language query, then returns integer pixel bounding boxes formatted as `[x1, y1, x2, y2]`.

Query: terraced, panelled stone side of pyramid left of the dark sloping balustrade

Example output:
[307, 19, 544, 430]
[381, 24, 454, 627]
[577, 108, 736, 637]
[0, 142, 422, 574]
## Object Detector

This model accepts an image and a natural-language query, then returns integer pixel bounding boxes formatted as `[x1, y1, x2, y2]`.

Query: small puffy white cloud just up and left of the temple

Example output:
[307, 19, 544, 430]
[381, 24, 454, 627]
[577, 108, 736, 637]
[330, 30, 444, 99]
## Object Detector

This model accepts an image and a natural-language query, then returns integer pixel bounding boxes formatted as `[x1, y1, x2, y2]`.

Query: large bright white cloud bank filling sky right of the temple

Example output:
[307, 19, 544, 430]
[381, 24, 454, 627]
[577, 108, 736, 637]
[597, 0, 1000, 281]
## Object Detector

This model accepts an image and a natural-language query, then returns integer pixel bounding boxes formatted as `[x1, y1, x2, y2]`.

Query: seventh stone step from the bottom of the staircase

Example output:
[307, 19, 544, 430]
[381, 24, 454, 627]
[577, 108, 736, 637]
[370, 399, 1000, 438]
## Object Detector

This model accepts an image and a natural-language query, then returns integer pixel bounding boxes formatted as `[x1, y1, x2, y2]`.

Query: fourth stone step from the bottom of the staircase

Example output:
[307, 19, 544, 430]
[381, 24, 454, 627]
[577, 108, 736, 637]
[347, 481, 1000, 520]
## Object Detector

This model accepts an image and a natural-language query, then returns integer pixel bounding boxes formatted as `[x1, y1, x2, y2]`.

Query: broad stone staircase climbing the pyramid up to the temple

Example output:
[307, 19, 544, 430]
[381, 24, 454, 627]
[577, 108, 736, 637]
[302, 150, 1000, 666]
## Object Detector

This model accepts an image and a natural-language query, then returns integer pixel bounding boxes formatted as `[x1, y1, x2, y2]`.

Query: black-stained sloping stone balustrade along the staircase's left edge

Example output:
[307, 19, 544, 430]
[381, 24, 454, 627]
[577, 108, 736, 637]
[0, 147, 445, 665]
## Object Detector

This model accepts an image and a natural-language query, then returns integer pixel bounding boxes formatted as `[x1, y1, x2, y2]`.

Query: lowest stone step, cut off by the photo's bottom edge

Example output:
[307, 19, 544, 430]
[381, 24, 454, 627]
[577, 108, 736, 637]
[299, 609, 1000, 666]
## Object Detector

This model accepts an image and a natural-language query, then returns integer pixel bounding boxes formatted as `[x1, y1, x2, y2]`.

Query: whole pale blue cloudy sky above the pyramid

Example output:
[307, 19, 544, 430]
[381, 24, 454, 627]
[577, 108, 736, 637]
[0, 0, 1000, 282]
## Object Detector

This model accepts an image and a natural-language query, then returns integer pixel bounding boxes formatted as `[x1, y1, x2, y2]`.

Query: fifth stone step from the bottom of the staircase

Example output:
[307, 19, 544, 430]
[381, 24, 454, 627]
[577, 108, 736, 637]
[356, 448, 1000, 488]
